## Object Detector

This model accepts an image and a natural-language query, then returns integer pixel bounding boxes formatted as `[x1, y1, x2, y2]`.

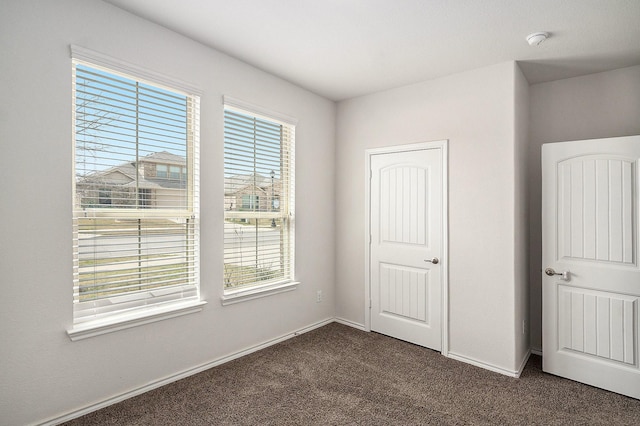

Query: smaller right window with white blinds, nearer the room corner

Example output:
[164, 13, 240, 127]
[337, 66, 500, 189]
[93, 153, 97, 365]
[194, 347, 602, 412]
[224, 97, 295, 295]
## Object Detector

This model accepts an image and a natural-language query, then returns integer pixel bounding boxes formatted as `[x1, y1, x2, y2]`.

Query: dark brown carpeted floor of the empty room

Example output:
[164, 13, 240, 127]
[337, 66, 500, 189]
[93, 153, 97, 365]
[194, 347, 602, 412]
[65, 323, 640, 425]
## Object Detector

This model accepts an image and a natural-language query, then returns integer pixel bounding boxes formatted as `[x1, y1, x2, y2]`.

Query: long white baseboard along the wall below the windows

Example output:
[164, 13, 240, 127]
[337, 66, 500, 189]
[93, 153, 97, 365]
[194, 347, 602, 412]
[39, 318, 336, 426]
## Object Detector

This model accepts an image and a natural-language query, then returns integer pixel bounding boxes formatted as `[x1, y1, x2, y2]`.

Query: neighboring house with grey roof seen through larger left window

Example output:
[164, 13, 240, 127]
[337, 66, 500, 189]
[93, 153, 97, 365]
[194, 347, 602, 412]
[76, 151, 188, 208]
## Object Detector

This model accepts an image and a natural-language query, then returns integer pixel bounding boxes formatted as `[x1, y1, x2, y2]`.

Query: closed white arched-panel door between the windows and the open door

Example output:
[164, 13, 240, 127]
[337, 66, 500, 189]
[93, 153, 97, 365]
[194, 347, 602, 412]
[369, 149, 443, 350]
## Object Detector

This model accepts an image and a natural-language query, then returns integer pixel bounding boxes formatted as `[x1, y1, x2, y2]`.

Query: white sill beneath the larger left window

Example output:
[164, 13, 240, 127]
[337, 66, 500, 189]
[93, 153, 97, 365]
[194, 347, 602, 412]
[67, 301, 207, 342]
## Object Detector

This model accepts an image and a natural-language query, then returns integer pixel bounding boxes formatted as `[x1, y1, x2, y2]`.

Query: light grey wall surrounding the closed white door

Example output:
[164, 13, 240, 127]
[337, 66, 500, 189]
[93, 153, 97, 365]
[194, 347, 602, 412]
[336, 62, 526, 372]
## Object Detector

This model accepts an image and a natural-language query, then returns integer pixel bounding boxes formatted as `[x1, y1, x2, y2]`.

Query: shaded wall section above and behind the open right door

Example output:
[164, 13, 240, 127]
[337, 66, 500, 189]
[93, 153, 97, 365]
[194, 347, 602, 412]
[528, 66, 640, 350]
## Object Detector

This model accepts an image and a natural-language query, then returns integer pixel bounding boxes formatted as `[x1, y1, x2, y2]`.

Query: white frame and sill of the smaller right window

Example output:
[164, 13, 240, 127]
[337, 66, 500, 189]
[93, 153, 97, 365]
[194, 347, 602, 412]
[221, 95, 300, 305]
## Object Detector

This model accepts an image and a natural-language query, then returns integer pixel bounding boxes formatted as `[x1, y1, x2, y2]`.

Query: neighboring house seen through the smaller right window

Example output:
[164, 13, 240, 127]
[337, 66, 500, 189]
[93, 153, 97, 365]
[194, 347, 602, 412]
[224, 173, 282, 212]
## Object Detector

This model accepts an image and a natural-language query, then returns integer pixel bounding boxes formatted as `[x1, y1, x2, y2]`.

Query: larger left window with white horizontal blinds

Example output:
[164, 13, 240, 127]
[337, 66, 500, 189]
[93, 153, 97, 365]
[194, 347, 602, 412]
[69, 47, 199, 332]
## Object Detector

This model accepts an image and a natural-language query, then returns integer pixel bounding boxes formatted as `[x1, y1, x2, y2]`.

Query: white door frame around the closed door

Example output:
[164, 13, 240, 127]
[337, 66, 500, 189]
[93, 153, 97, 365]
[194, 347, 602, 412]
[364, 139, 449, 356]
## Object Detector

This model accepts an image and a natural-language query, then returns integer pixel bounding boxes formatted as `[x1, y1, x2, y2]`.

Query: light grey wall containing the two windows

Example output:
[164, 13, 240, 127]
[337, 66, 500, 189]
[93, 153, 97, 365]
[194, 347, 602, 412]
[0, 0, 336, 425]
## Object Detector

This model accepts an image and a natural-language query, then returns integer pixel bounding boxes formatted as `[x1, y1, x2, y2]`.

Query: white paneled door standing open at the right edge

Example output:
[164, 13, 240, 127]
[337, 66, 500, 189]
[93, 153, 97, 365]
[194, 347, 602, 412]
[542, 136, 640, 398]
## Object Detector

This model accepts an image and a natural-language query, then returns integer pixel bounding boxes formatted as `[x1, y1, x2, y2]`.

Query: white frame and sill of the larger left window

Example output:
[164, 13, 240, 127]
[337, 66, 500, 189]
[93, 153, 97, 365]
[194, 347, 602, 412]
[67, 45, 206, 340]
